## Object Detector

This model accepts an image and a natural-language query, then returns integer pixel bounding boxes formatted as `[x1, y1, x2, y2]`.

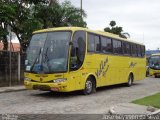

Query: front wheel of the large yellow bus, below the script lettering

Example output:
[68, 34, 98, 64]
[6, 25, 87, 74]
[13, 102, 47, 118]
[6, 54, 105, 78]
[83, 77, 96, 95]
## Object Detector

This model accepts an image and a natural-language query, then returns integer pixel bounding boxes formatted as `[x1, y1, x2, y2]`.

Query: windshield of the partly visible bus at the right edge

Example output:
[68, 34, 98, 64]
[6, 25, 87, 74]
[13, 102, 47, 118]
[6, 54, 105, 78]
[149, 56, 160, 69]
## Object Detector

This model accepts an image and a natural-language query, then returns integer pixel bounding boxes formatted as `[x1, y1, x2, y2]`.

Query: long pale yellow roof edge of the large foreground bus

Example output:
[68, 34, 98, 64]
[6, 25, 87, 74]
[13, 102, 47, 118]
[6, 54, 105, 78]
[33, 27, 144, 45]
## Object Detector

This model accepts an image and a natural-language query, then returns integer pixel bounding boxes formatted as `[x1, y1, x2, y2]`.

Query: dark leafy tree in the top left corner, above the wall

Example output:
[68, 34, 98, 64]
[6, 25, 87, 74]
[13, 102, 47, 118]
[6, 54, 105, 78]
[0, 0, 44, 50]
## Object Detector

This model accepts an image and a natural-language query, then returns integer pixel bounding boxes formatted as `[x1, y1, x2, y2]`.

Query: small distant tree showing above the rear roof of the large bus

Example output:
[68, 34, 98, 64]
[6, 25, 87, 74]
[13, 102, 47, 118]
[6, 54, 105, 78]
[104, 21, 130, 38]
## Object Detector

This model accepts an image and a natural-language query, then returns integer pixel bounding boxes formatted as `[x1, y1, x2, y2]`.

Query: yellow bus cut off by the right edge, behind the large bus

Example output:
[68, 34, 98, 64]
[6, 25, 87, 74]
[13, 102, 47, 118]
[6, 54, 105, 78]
[149, 54, 160, 78]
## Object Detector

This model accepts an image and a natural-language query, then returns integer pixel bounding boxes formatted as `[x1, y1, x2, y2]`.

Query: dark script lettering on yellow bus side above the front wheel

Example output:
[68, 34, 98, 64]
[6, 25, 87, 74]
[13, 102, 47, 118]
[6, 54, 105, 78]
[95, 57, 109, 77]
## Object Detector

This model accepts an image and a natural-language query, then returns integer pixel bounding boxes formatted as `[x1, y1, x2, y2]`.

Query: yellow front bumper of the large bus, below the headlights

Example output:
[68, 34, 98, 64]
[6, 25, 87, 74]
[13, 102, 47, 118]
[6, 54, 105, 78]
[24, 81, 69, 92]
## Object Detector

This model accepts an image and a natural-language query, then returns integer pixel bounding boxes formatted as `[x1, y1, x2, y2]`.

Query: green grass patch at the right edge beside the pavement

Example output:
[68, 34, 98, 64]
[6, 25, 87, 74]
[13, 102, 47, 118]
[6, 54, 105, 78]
[132, 93, 160, 108]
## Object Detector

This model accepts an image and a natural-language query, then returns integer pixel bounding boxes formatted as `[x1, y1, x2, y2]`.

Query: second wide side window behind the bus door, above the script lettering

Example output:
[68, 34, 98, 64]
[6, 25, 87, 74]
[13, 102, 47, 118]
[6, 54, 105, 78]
[101, 37, 112, 53]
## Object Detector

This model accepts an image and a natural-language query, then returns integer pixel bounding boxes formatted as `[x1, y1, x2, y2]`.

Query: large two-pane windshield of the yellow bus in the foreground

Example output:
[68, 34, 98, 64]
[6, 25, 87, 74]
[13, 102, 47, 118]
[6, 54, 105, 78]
[25, 32, 71, 73]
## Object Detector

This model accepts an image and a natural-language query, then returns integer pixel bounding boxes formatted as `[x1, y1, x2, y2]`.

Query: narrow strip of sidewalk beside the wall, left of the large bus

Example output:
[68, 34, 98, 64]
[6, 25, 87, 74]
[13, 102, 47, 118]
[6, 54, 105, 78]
[0, 85, 26, 93]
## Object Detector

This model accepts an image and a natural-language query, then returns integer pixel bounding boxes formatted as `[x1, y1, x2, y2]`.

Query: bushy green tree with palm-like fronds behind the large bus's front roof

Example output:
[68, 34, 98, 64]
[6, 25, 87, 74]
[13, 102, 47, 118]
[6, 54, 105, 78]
[34, 1, 86, 28]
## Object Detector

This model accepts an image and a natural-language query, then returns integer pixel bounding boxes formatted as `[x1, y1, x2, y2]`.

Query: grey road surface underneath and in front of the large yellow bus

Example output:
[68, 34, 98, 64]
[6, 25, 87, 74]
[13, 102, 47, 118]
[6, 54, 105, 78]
[0, 77, 160, 114]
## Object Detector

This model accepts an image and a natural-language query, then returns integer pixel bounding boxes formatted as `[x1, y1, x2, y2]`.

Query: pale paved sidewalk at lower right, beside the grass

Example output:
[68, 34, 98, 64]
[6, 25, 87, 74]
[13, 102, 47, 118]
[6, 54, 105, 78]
[109, 103, 160, 115]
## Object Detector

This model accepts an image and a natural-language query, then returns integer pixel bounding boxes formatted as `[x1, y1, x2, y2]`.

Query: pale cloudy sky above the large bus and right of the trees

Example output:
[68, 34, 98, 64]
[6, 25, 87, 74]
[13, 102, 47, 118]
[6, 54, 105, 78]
[59, 0, 160, 50]
